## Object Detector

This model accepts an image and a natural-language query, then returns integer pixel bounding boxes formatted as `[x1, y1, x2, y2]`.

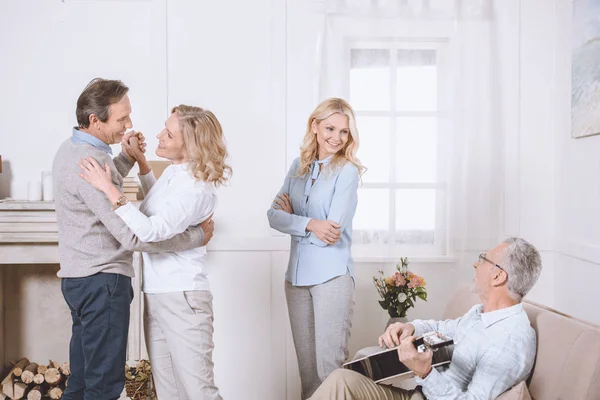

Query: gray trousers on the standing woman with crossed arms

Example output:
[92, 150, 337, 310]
[285, 275, 354, 399]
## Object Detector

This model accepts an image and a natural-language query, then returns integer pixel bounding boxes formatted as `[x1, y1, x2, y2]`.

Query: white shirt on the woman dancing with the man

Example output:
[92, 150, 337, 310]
[115, 164, 217, 293]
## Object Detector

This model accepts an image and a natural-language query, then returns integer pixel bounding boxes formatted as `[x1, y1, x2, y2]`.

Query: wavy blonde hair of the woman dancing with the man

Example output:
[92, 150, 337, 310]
[171, 104, 232, 186]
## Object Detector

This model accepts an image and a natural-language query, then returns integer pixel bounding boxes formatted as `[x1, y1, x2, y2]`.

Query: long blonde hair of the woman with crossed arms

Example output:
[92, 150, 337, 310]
[296, 97, 366, 176]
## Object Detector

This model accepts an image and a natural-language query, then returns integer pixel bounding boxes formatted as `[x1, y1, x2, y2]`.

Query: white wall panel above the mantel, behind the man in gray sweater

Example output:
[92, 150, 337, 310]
[0, 0, 167, 199]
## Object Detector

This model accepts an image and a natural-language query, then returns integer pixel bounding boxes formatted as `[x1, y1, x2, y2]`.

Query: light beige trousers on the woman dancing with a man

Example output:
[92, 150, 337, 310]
[144, 290, 222, 400]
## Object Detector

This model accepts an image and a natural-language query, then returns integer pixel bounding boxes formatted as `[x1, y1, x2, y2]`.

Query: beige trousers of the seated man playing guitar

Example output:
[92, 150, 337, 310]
[310, 369, 425, 400]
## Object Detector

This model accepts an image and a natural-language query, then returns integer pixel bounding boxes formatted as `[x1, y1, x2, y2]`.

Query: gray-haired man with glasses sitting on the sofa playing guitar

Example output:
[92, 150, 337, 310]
[311, 238, 542, 400]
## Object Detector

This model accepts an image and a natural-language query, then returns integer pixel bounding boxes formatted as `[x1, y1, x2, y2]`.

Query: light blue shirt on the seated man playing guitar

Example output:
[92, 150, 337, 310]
[411, 303, 536, 400]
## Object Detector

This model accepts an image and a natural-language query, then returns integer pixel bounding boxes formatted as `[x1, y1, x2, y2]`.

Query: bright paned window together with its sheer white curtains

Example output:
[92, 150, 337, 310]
[313, 0, 504, 258]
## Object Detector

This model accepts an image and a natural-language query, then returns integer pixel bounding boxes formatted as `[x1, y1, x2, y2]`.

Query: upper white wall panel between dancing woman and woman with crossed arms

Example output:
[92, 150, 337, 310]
[167, 0, 285, 238]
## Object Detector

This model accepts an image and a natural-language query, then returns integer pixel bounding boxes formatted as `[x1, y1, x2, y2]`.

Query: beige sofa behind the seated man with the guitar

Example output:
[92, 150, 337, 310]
[444, 288, 600, 400]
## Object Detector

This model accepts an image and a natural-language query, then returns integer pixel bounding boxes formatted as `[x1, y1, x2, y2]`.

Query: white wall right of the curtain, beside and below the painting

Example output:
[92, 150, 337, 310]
[507, 0, 600, 323]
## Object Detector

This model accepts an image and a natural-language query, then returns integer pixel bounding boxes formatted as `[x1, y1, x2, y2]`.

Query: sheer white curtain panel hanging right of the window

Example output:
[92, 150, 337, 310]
[451, 1, 505, 255]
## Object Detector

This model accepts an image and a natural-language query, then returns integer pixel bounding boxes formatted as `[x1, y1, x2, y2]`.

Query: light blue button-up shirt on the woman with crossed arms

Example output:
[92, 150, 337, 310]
[267, 157, 359, 286]
